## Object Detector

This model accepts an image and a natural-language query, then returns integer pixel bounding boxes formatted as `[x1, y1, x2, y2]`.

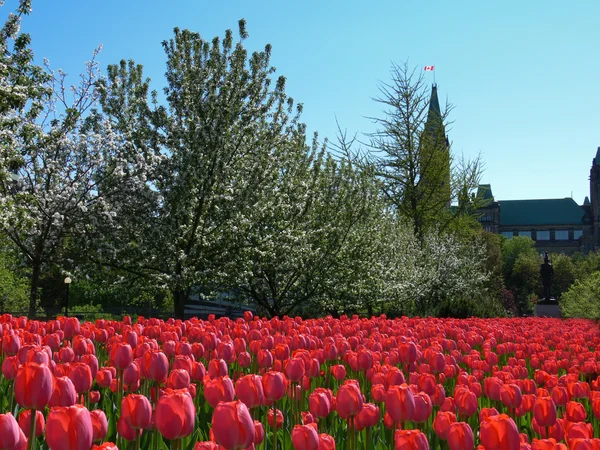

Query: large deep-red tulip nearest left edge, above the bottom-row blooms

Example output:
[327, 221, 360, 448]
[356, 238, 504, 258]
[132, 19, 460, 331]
[14, 363, 53, 409]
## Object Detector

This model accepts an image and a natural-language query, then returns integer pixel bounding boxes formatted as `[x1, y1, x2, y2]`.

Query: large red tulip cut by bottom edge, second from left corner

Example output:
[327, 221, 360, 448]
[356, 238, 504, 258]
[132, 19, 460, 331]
[46, 405, 93, 450]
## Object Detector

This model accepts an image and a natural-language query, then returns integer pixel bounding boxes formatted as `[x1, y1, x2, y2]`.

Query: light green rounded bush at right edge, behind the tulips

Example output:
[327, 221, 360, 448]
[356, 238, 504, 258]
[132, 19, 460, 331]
[560, 272, 600, 319]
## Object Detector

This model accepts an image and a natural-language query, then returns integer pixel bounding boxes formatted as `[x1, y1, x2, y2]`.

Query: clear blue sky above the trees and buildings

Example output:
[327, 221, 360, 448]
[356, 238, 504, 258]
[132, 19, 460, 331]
[9, 0, 600, 204]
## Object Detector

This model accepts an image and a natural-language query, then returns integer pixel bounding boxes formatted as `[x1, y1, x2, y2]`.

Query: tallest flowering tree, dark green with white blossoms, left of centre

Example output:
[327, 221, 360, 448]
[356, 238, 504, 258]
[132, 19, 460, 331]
[94, 20, 314, 317]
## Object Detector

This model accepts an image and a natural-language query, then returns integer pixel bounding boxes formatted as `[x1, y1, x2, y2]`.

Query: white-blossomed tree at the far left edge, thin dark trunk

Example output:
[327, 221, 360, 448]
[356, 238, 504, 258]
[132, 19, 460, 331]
[0, 1, 155, 317]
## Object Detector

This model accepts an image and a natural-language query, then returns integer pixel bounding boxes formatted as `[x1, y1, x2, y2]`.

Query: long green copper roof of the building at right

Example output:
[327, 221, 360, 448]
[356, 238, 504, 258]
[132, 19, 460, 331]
[499, 198, 585, 226]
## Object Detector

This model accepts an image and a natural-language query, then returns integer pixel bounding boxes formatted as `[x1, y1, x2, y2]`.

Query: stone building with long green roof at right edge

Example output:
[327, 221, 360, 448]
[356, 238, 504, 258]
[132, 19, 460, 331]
[477, 147, 600, 254]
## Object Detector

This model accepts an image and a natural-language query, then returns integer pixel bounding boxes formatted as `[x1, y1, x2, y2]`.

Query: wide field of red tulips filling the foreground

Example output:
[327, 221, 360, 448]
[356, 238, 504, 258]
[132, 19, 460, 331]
[0, 312, 600, 450]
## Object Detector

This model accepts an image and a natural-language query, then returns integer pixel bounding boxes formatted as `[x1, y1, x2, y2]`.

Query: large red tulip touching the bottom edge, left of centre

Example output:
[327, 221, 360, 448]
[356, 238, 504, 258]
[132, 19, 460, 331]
[212, 401, 256, 450]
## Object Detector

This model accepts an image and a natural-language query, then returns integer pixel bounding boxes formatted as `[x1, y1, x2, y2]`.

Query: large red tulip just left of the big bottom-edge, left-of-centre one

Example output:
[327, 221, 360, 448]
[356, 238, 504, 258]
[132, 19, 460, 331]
[154, 388, 196, 440]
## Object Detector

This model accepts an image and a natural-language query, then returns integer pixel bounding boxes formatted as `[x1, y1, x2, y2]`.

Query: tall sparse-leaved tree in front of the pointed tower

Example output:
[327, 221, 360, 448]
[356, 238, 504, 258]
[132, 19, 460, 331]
[369, 63, 482, 241]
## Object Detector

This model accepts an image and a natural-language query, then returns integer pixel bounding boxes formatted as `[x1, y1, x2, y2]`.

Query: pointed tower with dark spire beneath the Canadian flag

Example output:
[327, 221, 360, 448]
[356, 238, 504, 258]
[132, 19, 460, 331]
[419, 84, 451, 206]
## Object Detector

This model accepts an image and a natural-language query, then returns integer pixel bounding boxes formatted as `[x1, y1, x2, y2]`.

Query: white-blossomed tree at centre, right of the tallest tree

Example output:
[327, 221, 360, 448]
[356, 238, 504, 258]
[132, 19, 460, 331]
[238, 136, 381, 315]
